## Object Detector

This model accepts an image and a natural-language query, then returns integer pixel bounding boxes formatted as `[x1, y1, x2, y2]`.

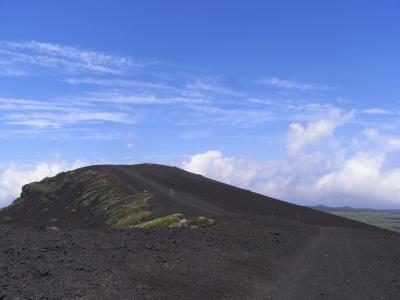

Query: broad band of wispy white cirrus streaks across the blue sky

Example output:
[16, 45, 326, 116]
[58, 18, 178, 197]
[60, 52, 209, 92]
[0, 41, 350, 128]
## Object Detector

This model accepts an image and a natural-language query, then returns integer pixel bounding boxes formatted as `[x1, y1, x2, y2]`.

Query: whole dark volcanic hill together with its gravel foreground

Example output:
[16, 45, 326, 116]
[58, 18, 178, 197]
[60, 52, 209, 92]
[0, 164, 400, 300]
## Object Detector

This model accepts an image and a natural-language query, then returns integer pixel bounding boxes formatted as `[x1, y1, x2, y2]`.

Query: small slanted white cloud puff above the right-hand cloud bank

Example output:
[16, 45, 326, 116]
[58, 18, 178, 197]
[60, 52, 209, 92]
[287, 109, 353, 154]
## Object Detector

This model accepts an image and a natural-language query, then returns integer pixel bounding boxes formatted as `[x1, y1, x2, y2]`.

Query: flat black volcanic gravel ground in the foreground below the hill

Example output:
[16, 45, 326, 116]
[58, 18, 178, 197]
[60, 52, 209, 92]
[0, 216, 400, 300]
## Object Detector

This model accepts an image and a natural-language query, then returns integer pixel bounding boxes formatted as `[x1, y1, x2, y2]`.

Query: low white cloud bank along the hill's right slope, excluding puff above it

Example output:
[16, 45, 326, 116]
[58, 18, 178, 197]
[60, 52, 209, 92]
[182, 151, 400, 208]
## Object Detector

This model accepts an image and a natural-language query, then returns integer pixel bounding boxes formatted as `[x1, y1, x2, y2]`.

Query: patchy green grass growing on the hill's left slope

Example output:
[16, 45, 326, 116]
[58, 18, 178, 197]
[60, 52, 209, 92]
[3, 169, 215, 229]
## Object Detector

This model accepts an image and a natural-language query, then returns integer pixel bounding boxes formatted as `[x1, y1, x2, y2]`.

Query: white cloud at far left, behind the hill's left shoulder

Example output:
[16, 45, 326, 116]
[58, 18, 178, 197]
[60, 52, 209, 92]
[0, 161, 85, 207]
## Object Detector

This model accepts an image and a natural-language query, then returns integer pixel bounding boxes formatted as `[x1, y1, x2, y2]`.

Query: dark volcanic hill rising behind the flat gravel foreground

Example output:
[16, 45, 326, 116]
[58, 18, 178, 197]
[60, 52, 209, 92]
[0, 164, 388, 231]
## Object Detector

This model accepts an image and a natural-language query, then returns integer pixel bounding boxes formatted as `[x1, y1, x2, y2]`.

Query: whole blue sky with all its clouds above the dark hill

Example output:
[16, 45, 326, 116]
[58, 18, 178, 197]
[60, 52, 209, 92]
[0, 0, 400, 207]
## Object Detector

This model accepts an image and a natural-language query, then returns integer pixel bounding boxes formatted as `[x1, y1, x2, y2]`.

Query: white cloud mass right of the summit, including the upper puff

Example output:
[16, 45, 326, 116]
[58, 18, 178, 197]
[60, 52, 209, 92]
[182, 110, 400, 208]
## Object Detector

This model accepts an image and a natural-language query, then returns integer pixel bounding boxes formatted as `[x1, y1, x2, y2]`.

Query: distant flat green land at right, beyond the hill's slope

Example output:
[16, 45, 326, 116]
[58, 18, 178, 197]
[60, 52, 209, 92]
[313, 206, 400, 232]
